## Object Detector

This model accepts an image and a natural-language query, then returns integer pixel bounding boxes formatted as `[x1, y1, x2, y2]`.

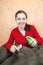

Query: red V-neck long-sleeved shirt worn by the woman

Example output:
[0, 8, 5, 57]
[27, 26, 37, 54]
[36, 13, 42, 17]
[5, 25, 43, 50]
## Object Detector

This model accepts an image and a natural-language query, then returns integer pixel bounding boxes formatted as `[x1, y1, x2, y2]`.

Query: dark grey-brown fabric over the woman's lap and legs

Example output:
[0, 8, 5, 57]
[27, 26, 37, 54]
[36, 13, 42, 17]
[0, 46, 41, 65]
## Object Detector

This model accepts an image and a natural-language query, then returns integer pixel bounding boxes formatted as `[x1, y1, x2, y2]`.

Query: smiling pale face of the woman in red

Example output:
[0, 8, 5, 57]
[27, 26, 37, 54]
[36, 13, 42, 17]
[16, 13, 27, 28]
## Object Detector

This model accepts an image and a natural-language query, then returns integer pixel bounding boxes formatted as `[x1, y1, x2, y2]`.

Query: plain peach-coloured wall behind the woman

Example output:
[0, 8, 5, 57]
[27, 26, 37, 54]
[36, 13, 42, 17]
[0, 0, 43, 46]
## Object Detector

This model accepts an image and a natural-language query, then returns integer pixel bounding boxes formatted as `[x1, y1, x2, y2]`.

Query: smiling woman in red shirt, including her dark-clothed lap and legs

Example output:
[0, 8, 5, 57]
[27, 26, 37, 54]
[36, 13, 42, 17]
[0, 10, 43, 65]
